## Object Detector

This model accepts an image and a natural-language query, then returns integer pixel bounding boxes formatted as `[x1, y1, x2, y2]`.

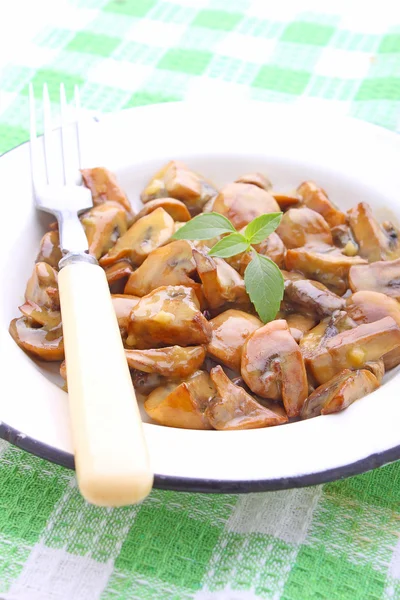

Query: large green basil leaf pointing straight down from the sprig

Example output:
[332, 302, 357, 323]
[244, 251, 284, 323]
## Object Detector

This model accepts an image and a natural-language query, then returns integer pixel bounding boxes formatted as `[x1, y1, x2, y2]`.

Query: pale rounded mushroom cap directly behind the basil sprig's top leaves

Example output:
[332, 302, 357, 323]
[213, 183, 280, 229]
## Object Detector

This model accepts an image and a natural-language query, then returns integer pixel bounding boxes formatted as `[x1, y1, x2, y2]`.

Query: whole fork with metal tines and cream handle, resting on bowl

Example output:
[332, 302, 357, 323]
[29, 85, 153, 506]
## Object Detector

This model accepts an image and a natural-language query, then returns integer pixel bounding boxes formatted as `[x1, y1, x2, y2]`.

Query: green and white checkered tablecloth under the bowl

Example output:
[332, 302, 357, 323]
[0, 0, 400, 600]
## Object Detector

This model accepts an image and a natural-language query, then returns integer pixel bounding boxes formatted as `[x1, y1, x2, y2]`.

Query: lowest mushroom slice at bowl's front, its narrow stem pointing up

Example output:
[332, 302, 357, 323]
[205, 365, 287, 431]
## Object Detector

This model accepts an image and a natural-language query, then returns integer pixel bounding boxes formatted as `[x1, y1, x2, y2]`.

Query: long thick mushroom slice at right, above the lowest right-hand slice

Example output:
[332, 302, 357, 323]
[308, 317, 400, 384]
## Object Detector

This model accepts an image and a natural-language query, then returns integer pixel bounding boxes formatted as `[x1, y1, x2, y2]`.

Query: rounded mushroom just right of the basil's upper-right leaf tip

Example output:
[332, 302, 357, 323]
[276, 206, 332, 248]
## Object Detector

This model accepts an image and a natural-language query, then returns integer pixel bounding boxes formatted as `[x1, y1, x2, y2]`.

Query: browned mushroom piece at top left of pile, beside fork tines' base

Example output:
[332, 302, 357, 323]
[81, 167, 132, 215]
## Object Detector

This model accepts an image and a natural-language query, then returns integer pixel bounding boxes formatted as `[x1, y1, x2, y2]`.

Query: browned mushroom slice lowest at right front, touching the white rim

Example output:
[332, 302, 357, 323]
[301, 369, 379, 419]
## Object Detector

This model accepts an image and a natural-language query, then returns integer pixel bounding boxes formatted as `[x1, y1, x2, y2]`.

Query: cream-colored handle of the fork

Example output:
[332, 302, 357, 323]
[58, 262, 153, 506]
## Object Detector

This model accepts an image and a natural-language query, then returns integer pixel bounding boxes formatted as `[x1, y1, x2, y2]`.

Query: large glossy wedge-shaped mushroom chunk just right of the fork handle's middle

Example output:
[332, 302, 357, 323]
[126, 285, 212, 349]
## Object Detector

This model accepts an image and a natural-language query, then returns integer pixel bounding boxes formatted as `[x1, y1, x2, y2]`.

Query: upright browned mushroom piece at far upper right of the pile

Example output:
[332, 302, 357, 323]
[347, 202, 398, 262]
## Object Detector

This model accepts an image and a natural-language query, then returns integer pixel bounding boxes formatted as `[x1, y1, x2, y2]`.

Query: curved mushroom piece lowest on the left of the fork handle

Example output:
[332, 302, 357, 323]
[9, 317, 64, 361]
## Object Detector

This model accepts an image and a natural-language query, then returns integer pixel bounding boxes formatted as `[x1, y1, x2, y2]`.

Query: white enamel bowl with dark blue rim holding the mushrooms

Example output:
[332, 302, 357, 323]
[0, 103, 400, 492]
